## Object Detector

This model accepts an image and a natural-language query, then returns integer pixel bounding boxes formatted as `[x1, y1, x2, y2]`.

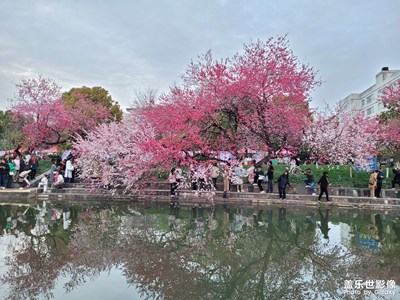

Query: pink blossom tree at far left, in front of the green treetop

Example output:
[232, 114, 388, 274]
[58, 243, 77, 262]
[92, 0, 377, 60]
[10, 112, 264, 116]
[11, 75, 110, 147]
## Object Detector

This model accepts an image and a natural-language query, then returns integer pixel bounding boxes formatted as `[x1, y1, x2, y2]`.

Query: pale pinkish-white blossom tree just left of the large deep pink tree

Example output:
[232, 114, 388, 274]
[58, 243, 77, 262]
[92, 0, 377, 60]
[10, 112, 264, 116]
[74, 114, 153, 192]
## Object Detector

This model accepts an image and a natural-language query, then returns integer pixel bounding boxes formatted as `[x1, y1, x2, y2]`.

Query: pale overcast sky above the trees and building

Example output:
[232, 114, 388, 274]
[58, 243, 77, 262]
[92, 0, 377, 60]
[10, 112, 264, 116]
[0, 0, 400, 109]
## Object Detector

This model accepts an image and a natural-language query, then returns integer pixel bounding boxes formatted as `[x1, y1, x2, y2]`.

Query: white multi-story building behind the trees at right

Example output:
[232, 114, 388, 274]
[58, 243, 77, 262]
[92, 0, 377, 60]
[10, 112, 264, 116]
[339, 67, 400, 117]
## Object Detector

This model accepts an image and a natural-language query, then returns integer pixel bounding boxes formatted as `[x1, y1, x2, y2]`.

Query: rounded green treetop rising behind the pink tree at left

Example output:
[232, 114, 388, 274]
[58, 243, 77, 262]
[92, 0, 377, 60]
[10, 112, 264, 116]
[62, 86, 122, 121]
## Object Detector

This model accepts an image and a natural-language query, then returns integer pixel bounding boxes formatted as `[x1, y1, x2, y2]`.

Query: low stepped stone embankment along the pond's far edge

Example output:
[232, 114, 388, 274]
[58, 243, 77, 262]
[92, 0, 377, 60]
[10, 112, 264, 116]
[0, 178, 400, 210]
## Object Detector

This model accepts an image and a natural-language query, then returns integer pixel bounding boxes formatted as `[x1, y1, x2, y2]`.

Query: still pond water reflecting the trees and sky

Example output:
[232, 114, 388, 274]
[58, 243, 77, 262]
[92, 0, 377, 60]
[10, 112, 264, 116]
[0, 203, 400, 299]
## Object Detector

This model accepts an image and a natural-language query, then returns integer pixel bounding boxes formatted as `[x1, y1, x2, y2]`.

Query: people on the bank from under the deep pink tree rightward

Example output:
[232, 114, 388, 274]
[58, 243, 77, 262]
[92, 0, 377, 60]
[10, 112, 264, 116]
[168, 161, 400, 201]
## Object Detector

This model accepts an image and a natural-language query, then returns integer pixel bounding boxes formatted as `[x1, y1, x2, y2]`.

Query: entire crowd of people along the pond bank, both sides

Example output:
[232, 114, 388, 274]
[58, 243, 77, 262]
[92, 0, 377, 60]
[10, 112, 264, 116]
[0, 147, 400, 201]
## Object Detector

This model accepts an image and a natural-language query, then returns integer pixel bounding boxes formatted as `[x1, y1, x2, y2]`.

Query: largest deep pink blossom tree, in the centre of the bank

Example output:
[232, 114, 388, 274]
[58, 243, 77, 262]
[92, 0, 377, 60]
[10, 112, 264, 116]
[145, 37, 319, 168]
